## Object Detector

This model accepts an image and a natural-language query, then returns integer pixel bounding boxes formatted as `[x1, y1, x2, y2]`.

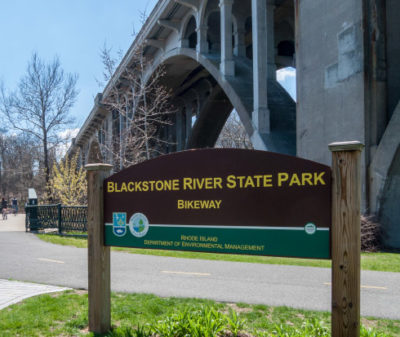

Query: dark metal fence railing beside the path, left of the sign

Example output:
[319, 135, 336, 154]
[25, 204, 87, 234]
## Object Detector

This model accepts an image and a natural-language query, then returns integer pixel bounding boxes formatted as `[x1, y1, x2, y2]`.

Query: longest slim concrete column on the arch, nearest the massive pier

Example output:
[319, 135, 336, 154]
[251, 0, 270, 134]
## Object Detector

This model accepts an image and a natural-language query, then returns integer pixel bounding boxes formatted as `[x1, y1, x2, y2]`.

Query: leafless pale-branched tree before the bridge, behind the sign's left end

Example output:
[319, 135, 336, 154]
[101, 46, 175, 170]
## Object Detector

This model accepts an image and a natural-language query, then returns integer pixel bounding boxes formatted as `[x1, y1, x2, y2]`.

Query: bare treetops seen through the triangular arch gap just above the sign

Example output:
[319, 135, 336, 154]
[215, 110, 253, 149]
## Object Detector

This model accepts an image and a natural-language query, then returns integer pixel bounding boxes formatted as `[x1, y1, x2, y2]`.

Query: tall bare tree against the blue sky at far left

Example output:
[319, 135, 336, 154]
[0, 53, 78, 183]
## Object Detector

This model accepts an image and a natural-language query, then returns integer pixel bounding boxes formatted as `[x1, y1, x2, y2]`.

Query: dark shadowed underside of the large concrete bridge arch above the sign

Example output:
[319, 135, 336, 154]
[163, 55, 233, 149]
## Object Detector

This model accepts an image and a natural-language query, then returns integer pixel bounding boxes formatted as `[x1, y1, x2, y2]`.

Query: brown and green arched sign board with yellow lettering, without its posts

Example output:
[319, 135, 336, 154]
[104, 149, 331, 259]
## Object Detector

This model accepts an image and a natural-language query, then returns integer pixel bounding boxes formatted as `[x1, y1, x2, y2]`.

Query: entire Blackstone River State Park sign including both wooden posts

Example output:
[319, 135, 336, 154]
[86, 142, 363, 337]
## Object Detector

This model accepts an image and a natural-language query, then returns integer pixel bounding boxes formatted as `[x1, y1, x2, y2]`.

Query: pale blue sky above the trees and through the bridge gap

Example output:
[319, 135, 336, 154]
[0, 0, 295, 134]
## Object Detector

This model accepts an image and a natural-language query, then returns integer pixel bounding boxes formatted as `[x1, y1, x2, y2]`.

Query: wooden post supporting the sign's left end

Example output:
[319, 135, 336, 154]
[85, 164, 112, 334]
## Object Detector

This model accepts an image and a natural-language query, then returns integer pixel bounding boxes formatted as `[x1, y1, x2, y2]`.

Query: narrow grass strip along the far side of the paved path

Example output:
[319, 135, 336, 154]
[37, 234, 400, 272]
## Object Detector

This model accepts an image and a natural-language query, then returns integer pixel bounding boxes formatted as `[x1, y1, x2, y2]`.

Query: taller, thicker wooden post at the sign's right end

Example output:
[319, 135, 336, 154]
[329, 141, 364, 337]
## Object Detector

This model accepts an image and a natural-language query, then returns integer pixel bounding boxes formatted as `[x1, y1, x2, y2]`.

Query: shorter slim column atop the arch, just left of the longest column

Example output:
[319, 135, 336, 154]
[219, 0, 235, 76]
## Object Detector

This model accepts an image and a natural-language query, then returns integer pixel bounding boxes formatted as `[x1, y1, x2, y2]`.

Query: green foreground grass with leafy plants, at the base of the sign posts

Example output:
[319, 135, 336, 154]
[0, 290, 400, 337]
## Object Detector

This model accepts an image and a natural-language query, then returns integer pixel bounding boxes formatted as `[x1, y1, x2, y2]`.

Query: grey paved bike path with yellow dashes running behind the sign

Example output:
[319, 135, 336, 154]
[0, 215, 400, 319]
